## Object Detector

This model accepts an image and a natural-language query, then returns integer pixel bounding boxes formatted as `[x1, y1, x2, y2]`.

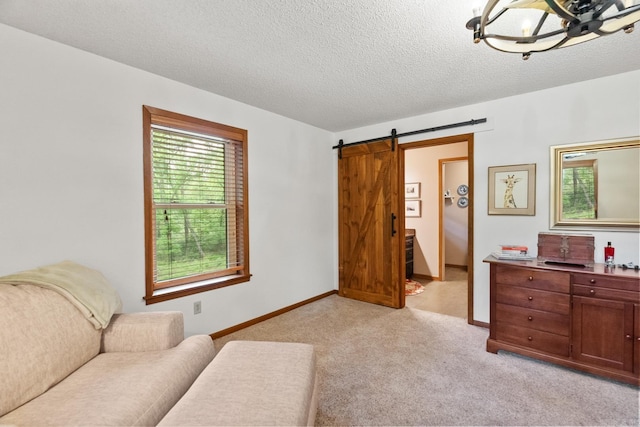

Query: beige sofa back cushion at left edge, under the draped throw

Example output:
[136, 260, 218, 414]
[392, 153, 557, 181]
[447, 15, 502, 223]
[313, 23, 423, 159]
[0, 284, 101, 416]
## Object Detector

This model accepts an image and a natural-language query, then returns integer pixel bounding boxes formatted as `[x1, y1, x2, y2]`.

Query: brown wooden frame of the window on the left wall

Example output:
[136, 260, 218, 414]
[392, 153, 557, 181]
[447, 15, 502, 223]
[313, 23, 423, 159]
[142, 105, 251, 305]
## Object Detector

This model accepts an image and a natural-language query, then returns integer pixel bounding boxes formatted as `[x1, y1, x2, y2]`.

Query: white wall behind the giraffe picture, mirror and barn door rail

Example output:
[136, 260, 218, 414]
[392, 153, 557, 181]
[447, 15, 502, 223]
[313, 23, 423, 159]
[337, 70, 640, 322]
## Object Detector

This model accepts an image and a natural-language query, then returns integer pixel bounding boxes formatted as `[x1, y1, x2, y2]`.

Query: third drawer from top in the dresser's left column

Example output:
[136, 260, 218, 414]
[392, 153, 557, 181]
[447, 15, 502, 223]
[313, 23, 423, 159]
[496, 304, 569, 337]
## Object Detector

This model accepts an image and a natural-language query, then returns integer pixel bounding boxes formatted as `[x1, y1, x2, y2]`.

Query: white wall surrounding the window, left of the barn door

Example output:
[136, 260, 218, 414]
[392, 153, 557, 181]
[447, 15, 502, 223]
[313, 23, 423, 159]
[0, 25, 337, 335]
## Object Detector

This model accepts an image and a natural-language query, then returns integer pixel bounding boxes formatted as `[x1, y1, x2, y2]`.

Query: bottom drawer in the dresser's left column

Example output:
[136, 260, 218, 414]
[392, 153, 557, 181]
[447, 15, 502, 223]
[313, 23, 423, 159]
[496, 322, 569, 356]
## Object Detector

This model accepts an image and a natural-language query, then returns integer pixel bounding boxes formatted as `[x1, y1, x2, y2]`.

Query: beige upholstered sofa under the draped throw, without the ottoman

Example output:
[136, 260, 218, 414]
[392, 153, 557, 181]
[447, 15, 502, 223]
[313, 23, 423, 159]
[0, 263, 215, 426]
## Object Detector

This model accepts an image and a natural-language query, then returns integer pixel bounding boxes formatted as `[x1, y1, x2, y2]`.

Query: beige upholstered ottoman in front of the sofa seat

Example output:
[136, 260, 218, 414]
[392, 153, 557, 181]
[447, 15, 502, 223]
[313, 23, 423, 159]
[159, 341, 317, 426]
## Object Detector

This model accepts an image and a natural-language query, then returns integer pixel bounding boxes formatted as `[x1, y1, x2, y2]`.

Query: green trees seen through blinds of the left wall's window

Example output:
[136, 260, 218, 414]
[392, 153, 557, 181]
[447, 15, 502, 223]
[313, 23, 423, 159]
[152, 128, 227, 281]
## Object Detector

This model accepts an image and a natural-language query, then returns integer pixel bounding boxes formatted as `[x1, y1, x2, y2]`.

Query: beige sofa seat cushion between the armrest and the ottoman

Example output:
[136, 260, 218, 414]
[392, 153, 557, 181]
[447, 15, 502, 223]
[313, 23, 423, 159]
[0, 336, 214, 426]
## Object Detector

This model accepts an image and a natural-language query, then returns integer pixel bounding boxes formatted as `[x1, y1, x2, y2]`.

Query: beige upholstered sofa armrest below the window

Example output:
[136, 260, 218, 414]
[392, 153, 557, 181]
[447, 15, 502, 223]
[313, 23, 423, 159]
[100, 311, 184, 353]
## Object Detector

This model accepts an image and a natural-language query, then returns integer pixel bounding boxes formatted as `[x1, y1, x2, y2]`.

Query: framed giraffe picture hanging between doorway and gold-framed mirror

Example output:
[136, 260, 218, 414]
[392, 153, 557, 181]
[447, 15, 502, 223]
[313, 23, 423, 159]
[489, 163, 536, 215]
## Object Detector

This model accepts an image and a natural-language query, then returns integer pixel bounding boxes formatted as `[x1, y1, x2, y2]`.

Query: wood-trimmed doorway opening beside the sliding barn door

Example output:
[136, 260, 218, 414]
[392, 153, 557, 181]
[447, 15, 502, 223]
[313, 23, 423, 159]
[399, 134, 473, 324]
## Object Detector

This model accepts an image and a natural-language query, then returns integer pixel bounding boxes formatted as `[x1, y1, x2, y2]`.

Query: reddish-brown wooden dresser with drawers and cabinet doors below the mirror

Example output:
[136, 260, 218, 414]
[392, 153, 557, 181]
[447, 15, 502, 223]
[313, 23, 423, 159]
[484, 256, 640, 385]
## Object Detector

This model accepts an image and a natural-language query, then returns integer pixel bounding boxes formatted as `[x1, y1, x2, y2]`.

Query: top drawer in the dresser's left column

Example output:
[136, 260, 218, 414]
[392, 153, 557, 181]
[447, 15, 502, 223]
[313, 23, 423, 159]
[496, 265, 571, 294]
